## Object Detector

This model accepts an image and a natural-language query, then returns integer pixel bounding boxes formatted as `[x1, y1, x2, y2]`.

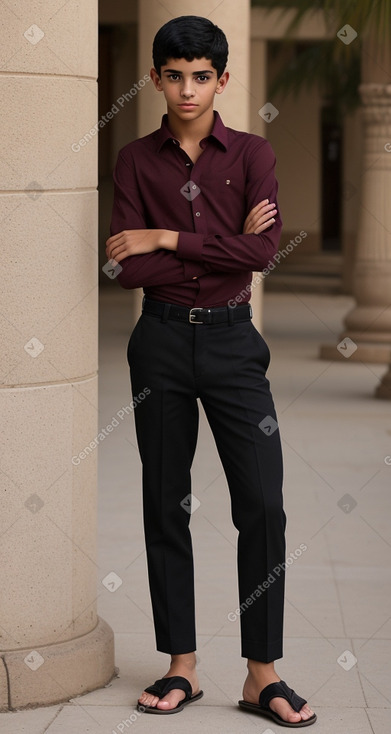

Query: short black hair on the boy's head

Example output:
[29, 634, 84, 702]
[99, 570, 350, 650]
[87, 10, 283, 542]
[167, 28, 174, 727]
[152, 15, 228, 79]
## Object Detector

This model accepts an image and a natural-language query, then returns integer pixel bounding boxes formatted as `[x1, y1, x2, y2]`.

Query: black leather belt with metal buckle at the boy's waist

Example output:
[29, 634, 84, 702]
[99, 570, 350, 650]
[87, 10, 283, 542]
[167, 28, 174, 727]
[143, 296, 253, 324]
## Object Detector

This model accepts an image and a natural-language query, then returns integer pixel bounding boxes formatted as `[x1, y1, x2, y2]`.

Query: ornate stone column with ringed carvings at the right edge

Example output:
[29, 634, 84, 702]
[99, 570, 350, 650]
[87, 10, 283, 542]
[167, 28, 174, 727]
[321, 83, 391, 362]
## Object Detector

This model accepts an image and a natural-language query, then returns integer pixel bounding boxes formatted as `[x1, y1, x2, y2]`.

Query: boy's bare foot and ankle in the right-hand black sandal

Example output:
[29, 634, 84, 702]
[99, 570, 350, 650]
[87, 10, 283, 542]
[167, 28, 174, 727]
[243, 660, 314, 724]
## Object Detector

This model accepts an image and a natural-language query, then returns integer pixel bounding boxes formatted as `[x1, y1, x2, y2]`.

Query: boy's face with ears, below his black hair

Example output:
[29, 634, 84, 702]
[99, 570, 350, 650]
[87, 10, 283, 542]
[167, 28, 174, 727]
[151, 58, 229, 120]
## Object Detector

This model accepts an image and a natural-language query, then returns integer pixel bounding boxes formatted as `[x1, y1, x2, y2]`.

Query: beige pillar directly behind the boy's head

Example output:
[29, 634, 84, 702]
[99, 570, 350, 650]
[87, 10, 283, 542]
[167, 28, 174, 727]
[138, 0, 262, 328]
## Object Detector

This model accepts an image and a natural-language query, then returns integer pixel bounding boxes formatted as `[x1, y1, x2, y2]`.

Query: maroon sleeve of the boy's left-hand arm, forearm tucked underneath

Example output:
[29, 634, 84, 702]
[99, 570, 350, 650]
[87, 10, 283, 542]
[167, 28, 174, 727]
[110, 152, 211, 288]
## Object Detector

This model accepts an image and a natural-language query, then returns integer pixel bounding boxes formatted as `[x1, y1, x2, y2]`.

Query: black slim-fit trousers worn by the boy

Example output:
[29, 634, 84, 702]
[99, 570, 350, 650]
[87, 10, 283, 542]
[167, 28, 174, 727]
[127, 304, 286, 662]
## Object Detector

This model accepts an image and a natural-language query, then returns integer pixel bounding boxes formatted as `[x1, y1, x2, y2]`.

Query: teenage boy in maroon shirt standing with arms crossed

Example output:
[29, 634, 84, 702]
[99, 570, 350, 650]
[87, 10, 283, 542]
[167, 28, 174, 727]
[106, 16, 316, 726]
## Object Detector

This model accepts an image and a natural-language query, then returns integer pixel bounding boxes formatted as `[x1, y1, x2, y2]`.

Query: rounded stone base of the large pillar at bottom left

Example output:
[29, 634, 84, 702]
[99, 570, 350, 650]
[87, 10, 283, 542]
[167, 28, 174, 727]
[0, 617, 115, 711]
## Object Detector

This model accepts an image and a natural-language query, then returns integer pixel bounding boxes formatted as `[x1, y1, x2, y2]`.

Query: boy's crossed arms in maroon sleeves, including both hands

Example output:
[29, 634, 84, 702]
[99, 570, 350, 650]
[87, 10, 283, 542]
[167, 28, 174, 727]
[106, 141, 282, 288]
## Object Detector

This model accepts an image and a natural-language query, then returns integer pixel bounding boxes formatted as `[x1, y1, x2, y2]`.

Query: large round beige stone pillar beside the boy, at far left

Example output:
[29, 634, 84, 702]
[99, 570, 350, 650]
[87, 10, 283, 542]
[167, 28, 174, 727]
[0, 0, 114, 711]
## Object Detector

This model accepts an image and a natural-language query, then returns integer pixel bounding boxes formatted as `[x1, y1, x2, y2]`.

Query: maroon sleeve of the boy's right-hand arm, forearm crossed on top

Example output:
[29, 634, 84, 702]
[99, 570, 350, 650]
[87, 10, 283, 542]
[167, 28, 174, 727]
[176, 140, 282, 272]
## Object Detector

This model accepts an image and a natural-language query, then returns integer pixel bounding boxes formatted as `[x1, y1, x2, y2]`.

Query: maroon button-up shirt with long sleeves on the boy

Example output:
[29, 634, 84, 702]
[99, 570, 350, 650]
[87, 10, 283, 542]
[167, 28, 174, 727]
[110, 111, 282, 307]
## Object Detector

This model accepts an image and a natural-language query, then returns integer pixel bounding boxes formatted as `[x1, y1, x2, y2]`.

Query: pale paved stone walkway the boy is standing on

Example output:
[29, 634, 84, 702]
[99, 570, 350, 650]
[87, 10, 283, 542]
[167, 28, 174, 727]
[0, 287, 391, 734]
